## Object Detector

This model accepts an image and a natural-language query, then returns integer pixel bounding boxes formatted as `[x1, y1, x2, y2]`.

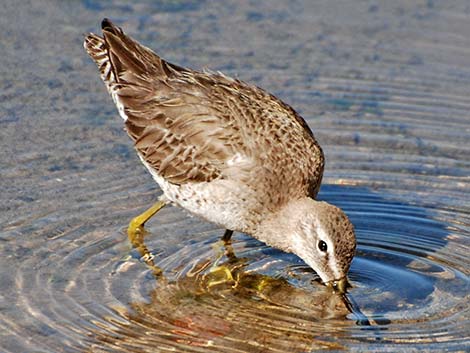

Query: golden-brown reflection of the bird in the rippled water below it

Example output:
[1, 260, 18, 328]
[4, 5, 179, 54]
[91, 238, 369, 352]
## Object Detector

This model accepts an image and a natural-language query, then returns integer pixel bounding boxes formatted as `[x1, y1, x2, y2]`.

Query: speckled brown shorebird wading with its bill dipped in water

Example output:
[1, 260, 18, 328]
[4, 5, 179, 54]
[84, 18, 356, 293]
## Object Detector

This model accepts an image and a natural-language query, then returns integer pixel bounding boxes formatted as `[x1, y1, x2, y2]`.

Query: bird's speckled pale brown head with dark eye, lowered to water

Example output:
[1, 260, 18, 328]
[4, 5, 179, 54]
[261, 198, 356, 293]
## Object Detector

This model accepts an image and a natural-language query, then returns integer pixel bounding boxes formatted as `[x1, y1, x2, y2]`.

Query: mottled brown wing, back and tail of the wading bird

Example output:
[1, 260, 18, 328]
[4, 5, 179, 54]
[84, 20, 323, 191]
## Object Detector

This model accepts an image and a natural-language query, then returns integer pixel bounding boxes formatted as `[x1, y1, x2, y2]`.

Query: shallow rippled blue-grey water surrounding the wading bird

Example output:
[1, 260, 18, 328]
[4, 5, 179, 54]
[0, 0, 470, 352]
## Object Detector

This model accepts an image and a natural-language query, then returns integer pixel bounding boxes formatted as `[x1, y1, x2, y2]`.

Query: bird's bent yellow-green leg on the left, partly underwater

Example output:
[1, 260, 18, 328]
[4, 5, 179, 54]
[127, 200, 166, 276]
